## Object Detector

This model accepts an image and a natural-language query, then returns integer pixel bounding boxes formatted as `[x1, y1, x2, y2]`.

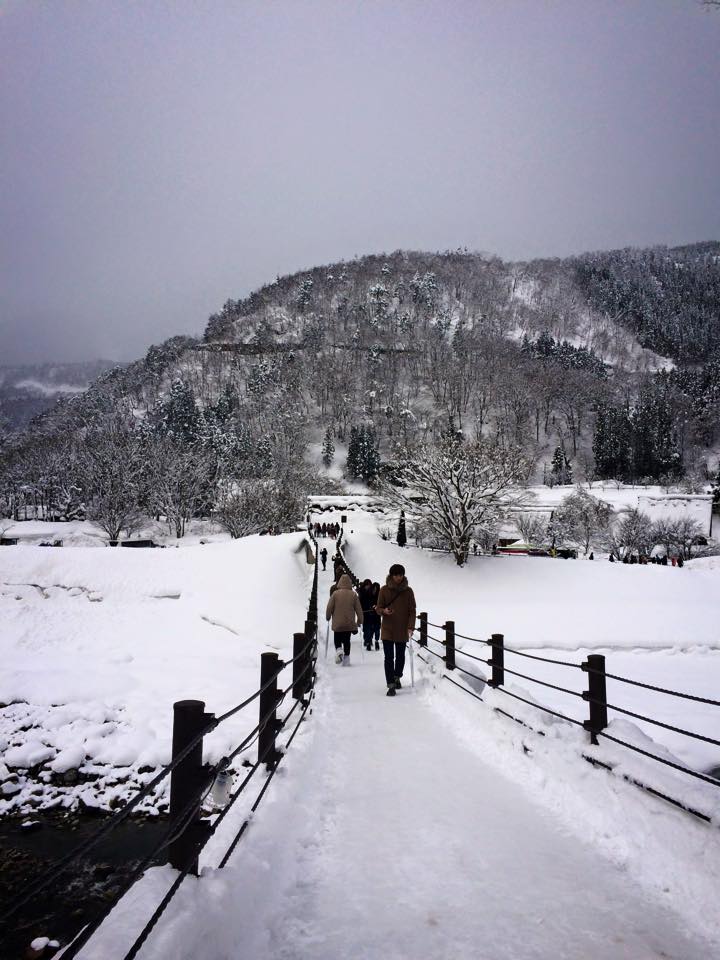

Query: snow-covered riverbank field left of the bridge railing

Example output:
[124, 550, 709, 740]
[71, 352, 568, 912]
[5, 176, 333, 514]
[0, 534, 312, 813]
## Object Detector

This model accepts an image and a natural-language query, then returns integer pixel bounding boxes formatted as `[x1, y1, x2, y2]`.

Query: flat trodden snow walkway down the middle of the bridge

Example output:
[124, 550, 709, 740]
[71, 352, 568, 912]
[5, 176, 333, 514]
[252, 624, 708, 960]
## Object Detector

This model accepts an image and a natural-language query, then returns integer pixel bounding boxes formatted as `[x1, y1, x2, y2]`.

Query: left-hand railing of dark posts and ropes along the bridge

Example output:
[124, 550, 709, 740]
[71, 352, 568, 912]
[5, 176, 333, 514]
[0, 537, 318, 960]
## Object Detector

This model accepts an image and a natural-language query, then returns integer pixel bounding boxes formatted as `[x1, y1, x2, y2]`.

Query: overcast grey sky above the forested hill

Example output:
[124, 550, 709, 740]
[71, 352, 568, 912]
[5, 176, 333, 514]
[0, 0, 720, 363]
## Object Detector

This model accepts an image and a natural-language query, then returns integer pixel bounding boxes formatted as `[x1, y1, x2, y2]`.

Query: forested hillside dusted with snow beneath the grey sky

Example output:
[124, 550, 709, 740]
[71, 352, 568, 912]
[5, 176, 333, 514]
[2, 243, 720, 529]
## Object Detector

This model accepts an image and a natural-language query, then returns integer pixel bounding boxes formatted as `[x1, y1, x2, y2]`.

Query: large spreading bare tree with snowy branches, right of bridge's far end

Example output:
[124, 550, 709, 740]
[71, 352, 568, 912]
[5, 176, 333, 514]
[382, 438, 527, 566]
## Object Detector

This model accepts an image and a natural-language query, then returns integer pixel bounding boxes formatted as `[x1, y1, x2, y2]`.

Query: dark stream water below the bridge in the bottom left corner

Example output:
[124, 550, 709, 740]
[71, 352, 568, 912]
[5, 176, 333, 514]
[0, 813, 168, 960]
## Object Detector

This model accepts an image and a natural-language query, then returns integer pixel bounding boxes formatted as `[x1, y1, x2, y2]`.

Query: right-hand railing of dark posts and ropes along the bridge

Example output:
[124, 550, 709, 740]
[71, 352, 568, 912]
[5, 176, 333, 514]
[415, 613, 720, 820]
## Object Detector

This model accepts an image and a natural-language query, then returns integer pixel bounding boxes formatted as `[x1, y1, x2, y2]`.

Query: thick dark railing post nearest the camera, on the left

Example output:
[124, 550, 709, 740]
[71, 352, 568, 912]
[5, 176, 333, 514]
[168, 700, 213, 876]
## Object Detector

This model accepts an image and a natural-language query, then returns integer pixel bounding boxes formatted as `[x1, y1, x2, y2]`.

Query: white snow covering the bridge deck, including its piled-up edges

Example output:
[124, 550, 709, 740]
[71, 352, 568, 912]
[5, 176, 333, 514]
[73, 550, 720, 960]
